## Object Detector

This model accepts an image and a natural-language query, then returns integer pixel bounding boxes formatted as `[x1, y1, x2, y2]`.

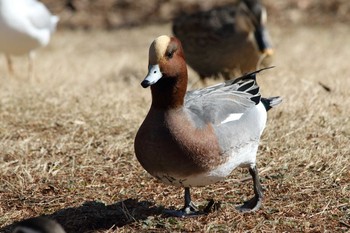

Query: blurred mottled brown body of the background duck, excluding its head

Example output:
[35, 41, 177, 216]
[173, 0, 260, 78]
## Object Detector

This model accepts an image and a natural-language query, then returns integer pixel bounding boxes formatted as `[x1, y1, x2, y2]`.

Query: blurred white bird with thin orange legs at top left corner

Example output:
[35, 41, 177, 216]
[0, 0, 59, 77]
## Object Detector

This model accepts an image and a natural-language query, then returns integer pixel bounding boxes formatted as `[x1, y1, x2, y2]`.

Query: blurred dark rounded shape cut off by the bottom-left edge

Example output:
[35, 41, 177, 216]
[13, 217, 66, 233]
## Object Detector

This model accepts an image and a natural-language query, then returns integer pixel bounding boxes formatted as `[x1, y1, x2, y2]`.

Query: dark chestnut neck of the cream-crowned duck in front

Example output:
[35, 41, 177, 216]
[151, 72, 187, 110]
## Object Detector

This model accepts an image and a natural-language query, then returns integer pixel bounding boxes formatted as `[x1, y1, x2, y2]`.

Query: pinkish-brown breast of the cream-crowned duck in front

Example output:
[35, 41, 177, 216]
[135, 107, 222, 186]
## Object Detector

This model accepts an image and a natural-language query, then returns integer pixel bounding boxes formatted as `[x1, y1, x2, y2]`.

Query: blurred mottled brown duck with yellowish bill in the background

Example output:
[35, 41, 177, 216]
[172, 0, 274, 83]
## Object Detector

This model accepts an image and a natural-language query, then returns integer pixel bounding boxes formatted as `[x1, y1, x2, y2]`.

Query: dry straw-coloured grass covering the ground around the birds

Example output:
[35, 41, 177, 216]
[0, 22, 350, 232]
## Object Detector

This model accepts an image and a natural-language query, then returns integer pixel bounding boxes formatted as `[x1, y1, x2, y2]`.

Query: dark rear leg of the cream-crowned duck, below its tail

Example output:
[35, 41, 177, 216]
[237, 165, 263, 212]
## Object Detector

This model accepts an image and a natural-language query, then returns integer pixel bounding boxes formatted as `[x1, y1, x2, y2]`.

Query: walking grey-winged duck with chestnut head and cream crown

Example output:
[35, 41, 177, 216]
[134, 35, 282, 217]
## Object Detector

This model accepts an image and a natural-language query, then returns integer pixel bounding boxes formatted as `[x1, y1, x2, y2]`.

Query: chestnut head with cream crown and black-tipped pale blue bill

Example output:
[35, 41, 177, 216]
[141, 35, 187, 88]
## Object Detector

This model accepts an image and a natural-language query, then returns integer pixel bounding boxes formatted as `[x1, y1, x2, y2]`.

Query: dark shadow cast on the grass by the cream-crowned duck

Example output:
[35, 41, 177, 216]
[0, 199, 164, 233]
